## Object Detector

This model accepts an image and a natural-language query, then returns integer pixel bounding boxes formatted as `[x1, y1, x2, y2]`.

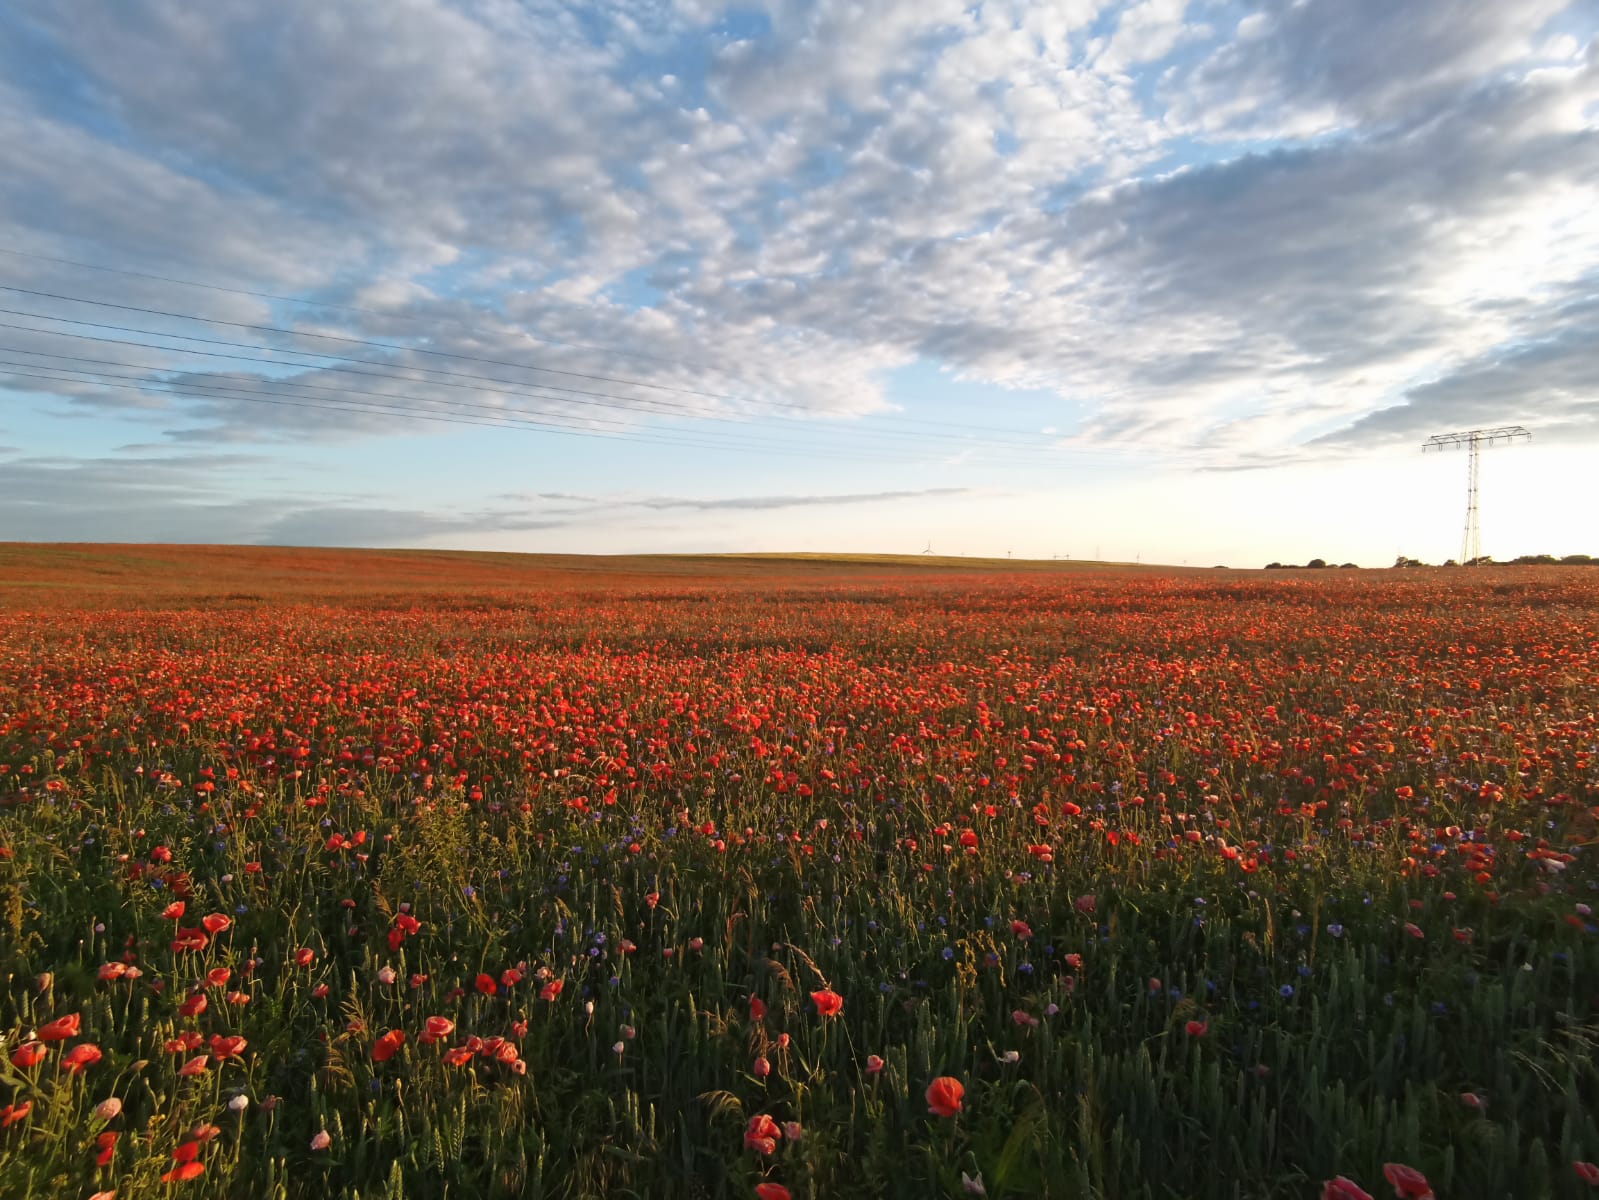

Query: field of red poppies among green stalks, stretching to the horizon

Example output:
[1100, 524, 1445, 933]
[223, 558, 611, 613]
[0, 560, 1599, 1200]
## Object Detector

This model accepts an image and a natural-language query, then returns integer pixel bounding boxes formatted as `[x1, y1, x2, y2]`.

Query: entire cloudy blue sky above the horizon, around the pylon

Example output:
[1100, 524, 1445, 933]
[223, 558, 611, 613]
[0, 0, 1599, 566]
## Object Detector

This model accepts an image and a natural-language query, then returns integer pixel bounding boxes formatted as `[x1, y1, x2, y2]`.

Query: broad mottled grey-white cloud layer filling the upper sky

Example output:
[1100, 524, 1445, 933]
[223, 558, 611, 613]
[0, 0, 1599, 480]
